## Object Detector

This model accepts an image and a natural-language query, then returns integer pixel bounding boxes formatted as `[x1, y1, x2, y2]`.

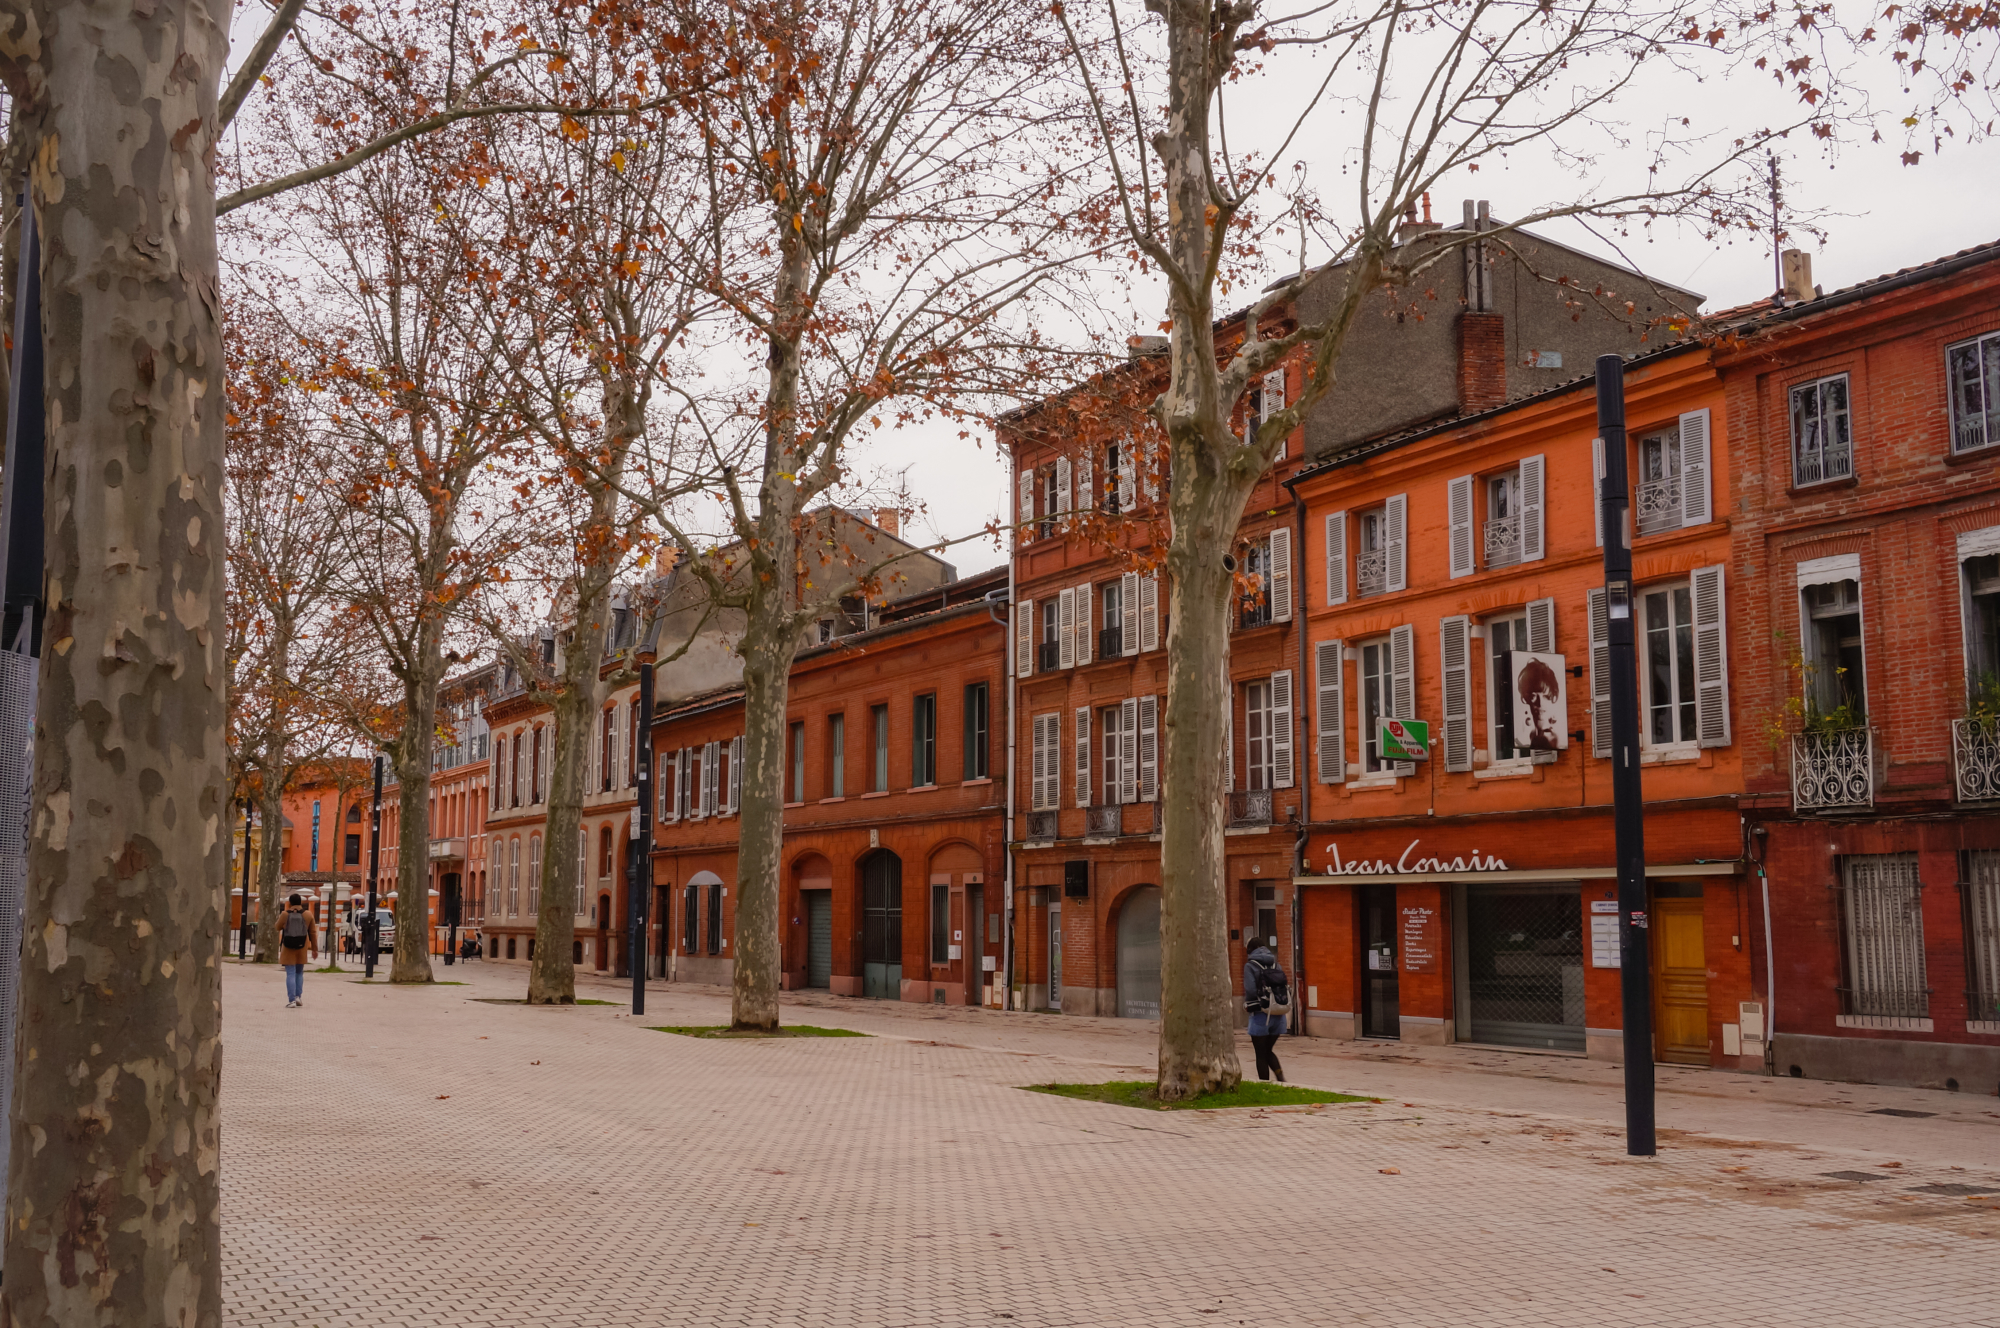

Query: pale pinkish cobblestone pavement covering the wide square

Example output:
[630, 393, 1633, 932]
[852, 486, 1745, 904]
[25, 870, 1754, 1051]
[234, 964, 2000, 1328]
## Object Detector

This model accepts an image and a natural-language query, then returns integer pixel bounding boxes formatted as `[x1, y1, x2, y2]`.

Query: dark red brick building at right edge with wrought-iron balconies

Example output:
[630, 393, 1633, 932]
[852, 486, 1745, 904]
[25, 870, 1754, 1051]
[1718, 246, 2000, 1094]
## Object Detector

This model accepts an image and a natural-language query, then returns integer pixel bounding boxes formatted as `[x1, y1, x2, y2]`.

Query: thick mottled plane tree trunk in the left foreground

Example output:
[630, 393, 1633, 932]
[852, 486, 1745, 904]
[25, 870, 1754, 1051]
[0, 0, 230, 1328]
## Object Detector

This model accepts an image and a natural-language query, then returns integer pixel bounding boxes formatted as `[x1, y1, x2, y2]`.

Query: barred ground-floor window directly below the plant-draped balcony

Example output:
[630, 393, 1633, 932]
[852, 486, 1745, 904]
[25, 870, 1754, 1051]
[1838, 854, 1930, 1028]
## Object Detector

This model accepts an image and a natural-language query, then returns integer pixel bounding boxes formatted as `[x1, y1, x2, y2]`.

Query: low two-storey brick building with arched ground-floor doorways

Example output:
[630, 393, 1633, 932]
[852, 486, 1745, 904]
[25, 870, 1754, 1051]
[644, 568, 1006, 1004]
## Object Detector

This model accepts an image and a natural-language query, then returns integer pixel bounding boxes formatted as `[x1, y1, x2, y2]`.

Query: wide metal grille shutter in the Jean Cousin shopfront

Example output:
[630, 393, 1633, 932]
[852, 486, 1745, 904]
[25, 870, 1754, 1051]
[1458, 884, 1584, 1052]
